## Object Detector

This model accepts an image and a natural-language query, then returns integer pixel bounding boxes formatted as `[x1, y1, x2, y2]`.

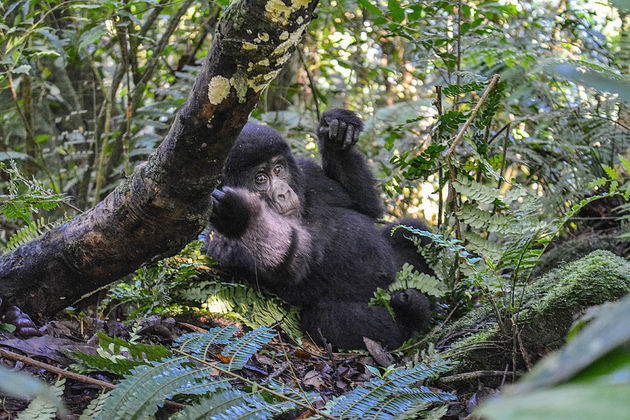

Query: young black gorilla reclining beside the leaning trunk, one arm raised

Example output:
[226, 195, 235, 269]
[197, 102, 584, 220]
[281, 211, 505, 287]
[207, 109, 430, 349]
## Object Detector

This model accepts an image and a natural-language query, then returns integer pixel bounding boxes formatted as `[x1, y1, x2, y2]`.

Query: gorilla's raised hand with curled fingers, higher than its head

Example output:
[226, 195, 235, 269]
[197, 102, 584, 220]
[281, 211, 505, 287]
[317, 108, 363, 150]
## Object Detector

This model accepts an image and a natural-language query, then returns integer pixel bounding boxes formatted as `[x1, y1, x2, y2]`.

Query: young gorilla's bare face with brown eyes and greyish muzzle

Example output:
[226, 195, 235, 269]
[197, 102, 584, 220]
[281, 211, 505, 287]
[248, 155, 302, 218]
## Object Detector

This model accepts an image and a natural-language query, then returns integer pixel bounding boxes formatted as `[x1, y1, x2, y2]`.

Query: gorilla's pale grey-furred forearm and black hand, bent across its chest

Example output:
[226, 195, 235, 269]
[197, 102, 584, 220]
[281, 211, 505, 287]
[208, 187, 311, 283]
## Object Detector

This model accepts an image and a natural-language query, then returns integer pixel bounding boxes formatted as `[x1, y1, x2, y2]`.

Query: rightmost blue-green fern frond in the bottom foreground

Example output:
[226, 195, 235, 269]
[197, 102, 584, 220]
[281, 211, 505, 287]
[331, 362, 455, 418]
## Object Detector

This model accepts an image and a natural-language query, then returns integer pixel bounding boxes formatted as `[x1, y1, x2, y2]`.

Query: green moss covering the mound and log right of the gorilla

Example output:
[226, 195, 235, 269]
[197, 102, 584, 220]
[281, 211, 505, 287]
[432, 250, 630, 371]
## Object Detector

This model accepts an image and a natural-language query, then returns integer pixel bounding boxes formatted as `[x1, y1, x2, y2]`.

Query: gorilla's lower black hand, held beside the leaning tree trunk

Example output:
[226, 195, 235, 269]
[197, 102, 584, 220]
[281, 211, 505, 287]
[210, 187, 261, 238]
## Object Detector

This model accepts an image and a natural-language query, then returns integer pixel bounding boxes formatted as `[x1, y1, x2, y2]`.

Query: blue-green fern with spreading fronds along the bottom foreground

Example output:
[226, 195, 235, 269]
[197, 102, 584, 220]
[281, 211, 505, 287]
[82, 326, 454, 420]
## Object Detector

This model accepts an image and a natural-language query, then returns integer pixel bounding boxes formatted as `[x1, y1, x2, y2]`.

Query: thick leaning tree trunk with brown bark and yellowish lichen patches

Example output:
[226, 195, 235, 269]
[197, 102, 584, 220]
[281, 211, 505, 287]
[0, 0, 317, 316]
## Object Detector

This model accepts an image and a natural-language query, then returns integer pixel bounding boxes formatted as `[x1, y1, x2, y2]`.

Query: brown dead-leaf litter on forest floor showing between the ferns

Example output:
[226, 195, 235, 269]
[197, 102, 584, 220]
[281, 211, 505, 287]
[0, 306, 488, 420]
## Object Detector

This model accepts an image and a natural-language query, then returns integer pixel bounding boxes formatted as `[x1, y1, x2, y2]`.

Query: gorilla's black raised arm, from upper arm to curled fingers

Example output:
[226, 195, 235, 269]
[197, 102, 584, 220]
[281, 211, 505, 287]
[317, 108, 383, 219]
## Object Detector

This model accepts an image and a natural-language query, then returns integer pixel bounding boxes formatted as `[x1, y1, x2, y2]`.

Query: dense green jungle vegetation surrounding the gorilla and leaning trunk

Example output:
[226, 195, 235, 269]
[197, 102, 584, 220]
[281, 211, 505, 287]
[0, 0, 630, 419]
